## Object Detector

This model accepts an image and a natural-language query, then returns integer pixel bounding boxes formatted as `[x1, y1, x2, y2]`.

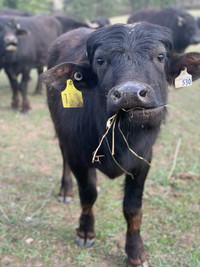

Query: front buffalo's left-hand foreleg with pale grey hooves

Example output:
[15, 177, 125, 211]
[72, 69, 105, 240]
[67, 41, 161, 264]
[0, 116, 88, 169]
[73, 167, 97, 248]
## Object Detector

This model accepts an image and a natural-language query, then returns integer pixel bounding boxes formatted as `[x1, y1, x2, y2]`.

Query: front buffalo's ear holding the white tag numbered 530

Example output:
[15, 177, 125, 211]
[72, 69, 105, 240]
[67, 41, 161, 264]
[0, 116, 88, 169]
[167, 52, 200, 85]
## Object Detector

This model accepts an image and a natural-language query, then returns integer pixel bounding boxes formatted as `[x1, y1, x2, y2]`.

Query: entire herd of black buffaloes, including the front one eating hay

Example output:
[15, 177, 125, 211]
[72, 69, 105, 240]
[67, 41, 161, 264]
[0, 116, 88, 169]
[0, 5, 200, 267]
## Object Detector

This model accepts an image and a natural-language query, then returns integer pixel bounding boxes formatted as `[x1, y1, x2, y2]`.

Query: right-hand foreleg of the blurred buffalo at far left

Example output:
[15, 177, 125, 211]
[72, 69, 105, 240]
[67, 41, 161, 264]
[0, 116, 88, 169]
[20, 70, 31, 113]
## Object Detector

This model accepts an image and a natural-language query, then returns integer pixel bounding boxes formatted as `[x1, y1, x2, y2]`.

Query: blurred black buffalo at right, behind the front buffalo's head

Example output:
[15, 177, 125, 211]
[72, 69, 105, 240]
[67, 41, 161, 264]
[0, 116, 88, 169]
[127, 7, 200, 53]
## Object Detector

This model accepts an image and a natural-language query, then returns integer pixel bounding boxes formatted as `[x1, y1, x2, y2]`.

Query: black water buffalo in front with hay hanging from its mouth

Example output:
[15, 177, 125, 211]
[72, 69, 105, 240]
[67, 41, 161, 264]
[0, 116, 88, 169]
[41, 22, 200, 266]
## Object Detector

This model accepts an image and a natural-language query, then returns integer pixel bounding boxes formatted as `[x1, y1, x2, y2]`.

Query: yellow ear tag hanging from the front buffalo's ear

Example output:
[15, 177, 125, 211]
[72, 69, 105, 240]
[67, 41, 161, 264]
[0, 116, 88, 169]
[61, 79, 83, 108]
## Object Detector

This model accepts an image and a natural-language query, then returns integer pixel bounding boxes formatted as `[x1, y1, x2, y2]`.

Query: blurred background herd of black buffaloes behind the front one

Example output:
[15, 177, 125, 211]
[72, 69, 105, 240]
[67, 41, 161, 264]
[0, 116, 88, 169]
[0, 8, 200, 113]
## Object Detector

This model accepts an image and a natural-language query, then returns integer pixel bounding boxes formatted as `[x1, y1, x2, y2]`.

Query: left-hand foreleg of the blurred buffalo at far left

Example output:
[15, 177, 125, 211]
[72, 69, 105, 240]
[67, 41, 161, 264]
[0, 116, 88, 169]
[5, 69, 19, 109]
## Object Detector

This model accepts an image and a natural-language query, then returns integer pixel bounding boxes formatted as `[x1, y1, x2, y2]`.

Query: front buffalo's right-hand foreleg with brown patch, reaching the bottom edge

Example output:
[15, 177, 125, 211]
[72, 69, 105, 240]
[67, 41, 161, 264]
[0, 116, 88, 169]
[123, 163, 149, 267]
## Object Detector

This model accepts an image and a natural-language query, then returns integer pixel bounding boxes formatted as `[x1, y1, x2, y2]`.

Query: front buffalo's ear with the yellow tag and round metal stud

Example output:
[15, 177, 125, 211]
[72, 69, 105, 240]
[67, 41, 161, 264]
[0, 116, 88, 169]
[40, 62, 96, 91]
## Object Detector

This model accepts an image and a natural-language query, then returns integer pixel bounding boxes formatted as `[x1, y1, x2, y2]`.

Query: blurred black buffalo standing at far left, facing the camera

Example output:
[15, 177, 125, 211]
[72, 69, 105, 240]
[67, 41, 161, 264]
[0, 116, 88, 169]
[0, 15, 62, 112]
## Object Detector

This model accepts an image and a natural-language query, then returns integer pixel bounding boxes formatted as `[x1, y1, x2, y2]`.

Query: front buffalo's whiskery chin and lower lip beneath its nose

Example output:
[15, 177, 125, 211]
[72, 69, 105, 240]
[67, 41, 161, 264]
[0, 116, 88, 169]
[120, 106, 167, 128]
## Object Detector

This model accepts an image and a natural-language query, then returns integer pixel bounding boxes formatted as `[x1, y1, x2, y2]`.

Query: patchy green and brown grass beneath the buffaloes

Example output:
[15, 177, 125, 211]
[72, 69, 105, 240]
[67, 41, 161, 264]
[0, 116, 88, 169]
[0, 43, 200, 267]
